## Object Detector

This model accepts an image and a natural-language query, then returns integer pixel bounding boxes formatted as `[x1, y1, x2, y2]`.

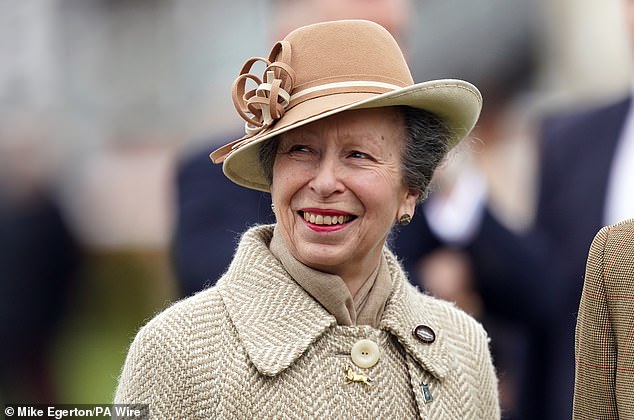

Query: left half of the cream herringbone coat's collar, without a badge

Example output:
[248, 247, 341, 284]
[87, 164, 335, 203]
[218, 226, 336, 376]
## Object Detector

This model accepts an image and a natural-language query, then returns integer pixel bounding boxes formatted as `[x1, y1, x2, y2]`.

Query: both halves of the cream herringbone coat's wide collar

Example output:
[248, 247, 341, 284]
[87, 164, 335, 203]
[218, 226, 453, 378]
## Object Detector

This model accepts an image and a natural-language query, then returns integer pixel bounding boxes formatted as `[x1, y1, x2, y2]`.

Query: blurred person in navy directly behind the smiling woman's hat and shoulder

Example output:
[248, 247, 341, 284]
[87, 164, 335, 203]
[171, 0, 410, 296]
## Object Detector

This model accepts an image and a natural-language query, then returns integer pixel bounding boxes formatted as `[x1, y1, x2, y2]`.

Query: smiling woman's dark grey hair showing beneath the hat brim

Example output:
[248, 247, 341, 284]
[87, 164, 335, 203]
[259, 106, 450, 202]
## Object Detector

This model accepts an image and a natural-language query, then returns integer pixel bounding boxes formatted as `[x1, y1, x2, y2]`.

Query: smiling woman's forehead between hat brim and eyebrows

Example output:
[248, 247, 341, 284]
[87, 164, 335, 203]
[281, 107, 405, 140]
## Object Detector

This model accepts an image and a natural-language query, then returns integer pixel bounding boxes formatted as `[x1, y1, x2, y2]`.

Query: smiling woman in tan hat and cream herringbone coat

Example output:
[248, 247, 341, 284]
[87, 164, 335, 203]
[116, 21, 500, 419]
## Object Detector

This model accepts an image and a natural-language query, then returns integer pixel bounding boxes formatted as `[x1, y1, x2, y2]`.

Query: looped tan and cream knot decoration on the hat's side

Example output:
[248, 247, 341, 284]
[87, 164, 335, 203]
[232, 41, 295, 136]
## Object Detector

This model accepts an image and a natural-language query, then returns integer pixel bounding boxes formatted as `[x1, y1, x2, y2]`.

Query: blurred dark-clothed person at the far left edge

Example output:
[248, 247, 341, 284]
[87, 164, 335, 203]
[0, 124, 81, 403]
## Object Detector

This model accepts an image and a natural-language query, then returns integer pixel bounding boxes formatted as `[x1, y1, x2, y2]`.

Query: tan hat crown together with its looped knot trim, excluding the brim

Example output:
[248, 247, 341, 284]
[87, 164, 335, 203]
[226, 20, 414, 136]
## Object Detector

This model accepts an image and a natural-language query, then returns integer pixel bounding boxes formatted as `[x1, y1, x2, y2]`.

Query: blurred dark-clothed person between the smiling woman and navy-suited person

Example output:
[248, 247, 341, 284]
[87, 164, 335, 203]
[393, 36, 544, 420]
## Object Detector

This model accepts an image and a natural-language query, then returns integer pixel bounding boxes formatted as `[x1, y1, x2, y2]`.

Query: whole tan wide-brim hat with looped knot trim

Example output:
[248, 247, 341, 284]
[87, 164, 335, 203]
[210, 20, 482, 191]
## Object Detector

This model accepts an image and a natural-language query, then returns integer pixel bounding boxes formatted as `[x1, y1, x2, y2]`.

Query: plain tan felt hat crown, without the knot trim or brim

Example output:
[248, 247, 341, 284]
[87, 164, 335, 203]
[277, 20, 414, 93]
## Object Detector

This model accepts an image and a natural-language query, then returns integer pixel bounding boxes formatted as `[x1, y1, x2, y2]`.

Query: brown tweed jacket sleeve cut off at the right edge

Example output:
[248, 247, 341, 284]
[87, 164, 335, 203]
[573, 219, 634, 420]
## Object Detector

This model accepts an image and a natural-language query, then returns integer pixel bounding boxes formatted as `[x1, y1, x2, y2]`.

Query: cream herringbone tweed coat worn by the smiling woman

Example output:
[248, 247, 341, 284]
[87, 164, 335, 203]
[115, 226, 500, 419]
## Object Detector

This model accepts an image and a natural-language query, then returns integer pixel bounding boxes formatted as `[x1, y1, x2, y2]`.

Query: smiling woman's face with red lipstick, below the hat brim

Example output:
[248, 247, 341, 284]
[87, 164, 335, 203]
[271, 108, 417, 280]
